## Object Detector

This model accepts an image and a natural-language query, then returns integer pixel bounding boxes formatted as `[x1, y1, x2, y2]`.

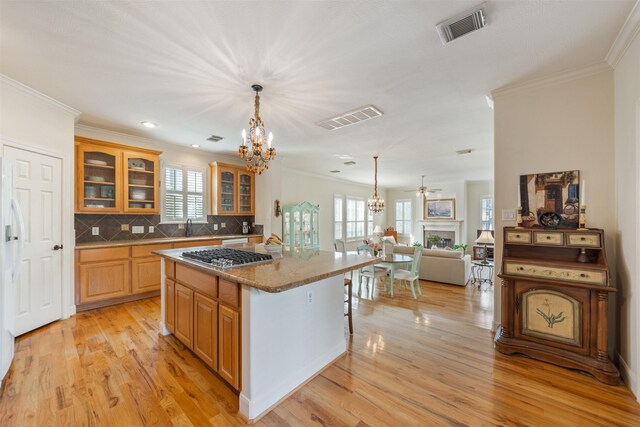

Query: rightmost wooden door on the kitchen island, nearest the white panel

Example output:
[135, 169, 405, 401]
[218, 305, 240, 390]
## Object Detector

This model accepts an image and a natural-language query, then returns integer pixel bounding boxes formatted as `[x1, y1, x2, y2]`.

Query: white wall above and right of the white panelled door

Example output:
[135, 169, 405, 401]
[0, 75, 79, 318]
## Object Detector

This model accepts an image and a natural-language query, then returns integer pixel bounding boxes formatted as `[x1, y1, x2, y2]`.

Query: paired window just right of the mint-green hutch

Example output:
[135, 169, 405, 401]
[333, 194, 373, 240]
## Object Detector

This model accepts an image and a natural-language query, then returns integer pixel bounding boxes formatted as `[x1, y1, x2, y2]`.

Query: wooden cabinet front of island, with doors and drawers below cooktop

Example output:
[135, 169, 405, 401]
[165, 261, 241, 390]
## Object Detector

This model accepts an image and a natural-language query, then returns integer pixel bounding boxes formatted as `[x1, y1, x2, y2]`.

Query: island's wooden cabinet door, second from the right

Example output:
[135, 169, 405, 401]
[193, 292, 218, 370]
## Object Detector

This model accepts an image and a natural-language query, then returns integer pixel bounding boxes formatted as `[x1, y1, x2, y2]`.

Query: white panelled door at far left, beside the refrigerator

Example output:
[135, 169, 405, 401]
[4, 146, 62, 335]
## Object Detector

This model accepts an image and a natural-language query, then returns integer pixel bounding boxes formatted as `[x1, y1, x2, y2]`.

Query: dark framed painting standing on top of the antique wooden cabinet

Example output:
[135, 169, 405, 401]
[518, 170, 580, 228]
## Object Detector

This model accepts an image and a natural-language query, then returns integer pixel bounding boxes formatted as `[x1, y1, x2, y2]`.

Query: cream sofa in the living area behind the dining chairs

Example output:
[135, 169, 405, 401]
[393, 246, 471, 286]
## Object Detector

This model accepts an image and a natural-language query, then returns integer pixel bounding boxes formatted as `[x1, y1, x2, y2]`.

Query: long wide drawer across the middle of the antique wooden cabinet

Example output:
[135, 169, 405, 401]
[504, 261, 607, 286]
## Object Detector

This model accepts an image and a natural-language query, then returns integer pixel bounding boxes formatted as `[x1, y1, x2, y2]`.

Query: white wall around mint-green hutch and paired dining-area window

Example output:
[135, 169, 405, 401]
[278, 169, 392, 251]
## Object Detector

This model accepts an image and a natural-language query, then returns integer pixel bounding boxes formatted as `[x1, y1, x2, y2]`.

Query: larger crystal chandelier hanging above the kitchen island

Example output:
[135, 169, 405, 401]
[238, 85, 276, 175]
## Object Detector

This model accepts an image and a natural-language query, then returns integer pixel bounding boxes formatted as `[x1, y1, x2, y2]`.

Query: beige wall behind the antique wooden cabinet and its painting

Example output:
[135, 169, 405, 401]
[493, 66, 617, 348]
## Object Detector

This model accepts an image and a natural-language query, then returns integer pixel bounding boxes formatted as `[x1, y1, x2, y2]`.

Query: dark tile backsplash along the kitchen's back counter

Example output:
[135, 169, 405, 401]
[74, 214, 264, 243]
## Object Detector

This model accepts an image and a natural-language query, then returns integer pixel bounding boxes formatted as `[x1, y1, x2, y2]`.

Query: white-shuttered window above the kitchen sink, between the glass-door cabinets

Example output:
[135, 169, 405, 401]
[162, 166, 207, 222]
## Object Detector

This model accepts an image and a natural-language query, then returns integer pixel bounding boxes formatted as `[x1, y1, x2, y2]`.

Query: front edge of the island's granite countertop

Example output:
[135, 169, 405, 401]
[153, 249, 379, 294]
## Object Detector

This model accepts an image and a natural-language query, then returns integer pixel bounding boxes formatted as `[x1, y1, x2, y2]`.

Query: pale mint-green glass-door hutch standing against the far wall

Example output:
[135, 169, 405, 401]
[282, 202, 320, 249]
